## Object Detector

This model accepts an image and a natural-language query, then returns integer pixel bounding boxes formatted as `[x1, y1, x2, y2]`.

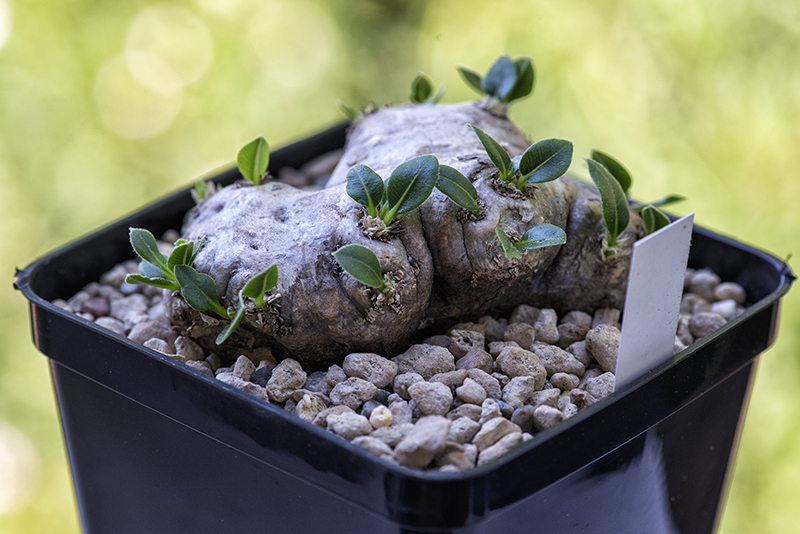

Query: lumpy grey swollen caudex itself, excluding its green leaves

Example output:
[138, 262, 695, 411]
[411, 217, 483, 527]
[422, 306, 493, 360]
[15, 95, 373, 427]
[167, 103, 642, 369]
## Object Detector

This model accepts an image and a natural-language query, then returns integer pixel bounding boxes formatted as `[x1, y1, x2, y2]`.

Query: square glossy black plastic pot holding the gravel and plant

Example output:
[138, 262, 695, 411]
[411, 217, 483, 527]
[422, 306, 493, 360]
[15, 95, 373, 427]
[17, 126, 793, 534]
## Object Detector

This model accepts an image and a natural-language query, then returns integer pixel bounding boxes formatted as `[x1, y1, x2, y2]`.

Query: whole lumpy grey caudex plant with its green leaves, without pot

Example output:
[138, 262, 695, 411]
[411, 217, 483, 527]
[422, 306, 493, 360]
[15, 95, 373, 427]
[129, 55, 680, 368]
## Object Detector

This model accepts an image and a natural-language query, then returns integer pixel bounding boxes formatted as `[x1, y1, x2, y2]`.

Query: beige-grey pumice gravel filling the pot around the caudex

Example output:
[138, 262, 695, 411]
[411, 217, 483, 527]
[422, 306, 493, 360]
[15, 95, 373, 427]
[54, 241, 747, 471]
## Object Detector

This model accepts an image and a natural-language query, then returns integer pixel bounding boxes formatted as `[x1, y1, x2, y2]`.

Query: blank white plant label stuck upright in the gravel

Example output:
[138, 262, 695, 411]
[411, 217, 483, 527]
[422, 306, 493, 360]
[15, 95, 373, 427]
[614, 213, 694, 389]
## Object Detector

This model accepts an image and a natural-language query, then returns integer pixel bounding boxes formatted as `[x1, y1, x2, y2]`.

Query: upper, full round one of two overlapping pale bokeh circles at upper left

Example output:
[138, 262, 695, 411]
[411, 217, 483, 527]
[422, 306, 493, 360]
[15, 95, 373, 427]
[125, 3, 214, 92]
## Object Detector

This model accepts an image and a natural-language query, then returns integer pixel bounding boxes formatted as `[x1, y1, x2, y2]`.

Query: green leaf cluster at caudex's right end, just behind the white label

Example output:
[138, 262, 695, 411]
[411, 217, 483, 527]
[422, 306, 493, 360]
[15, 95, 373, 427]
[586, 150, 684, 256]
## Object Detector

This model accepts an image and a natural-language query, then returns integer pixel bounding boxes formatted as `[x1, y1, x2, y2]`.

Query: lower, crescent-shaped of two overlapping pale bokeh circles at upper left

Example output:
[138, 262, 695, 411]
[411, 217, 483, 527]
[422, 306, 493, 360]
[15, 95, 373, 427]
[94, 55, 183, 139]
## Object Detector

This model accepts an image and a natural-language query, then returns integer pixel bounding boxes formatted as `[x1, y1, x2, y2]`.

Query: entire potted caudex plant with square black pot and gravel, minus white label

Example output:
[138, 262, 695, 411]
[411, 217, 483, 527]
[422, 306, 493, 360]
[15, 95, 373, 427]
[17, 56, 792, 532]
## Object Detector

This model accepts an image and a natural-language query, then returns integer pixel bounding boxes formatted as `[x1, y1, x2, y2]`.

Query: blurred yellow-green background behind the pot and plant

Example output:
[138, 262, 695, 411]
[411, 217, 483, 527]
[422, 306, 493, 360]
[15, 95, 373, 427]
[0, 0, 800, 534]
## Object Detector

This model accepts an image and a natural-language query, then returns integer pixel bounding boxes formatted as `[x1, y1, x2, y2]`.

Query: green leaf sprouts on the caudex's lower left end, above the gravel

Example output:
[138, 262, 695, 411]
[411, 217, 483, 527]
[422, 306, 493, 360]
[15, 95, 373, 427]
[125, 228, 278, 345]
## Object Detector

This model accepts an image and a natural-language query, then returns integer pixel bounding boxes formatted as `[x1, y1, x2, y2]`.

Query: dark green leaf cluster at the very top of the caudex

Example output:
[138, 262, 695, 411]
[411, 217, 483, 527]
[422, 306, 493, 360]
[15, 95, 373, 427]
[456, 54, 535, 105]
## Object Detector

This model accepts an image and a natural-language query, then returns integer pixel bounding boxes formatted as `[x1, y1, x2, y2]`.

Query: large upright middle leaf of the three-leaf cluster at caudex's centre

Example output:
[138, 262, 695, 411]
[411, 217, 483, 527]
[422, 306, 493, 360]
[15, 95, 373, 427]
[383, 154, 439, 226]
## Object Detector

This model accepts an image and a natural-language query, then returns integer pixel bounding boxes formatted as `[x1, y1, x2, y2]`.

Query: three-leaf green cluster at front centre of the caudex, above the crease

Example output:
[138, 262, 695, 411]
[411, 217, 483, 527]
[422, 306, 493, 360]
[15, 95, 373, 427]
[347, 154, 480, 227]
